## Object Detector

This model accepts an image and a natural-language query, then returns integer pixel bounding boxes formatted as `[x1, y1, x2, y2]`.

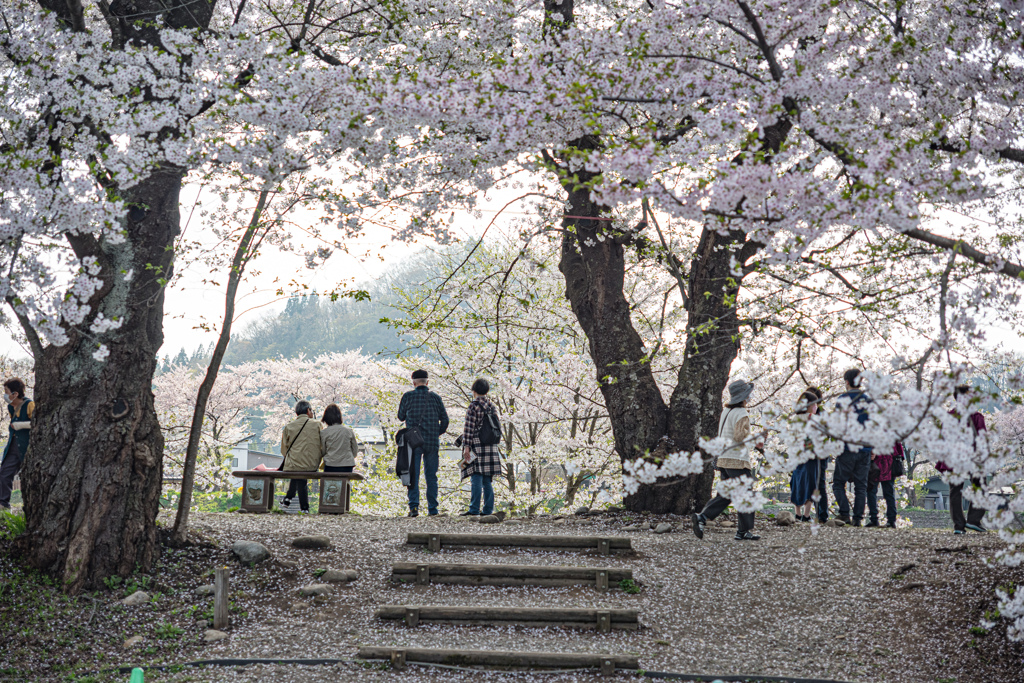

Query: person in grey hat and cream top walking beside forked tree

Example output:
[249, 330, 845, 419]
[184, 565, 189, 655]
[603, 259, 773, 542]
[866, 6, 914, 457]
[692, 380, 764, 541]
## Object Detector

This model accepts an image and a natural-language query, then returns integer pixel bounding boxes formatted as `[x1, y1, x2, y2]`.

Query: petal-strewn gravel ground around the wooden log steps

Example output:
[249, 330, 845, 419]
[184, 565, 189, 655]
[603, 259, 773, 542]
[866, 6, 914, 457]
[128, 513, 1024, 683]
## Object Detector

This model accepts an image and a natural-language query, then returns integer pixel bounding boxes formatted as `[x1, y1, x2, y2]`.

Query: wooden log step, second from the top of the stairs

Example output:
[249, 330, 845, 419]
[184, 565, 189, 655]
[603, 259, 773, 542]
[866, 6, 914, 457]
[391, 562, 633, 591]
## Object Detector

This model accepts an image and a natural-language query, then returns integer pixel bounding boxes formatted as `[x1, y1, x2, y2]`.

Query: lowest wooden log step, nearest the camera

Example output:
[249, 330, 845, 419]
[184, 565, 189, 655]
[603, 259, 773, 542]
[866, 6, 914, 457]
[357, 647, 640, 674]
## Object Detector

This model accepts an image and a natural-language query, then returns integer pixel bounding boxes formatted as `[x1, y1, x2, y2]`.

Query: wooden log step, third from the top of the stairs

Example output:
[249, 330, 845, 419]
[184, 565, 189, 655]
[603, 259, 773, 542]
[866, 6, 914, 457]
[377, 605, 640, 633]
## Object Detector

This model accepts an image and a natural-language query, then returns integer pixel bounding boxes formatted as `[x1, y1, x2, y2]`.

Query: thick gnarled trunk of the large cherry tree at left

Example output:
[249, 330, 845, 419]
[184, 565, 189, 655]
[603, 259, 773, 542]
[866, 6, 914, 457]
[18, 166, 184, 593]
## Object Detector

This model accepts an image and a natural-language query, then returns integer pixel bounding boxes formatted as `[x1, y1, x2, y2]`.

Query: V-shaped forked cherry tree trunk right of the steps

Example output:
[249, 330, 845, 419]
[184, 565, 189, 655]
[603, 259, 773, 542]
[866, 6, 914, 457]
[559, 174, 758, 514]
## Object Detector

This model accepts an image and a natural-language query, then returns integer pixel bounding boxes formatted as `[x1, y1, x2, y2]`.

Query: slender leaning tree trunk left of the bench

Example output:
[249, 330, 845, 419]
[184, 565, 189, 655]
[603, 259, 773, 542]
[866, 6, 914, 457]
[171, 189, 270, 546]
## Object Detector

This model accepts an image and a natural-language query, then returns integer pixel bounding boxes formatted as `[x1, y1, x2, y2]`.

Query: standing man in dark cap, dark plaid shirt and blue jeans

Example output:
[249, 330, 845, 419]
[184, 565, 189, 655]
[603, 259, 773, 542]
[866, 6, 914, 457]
[398, 370, 449, 517]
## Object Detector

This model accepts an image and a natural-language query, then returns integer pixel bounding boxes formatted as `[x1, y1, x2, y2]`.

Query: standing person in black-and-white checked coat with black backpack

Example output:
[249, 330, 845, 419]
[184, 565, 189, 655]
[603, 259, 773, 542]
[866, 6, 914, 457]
[462, 379, 502, 517]
